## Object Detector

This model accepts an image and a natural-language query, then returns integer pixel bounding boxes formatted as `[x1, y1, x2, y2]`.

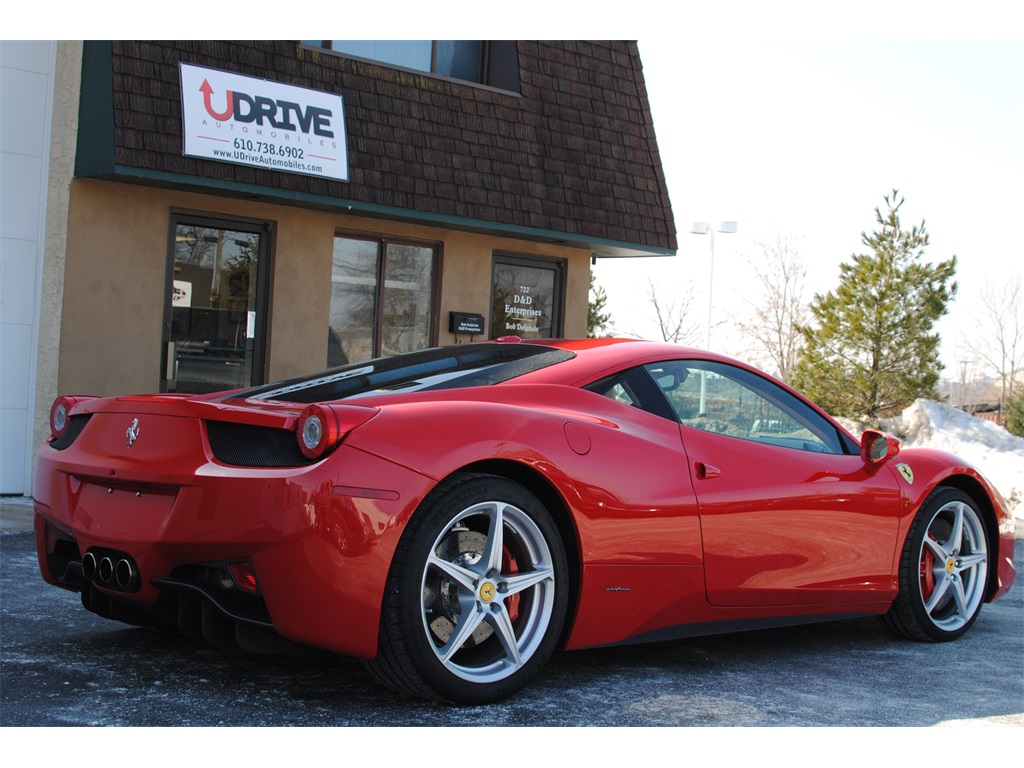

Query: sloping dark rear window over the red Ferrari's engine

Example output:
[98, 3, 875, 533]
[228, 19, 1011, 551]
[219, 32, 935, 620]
[239, 344, 575, 403]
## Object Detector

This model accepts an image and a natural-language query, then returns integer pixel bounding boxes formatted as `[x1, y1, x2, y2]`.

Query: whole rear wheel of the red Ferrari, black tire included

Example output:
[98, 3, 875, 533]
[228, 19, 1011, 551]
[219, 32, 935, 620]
[370, 474, 568, 705]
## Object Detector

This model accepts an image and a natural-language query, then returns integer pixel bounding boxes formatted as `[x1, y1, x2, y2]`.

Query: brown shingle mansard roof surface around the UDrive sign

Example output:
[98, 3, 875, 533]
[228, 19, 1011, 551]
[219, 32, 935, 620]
[96, 41, 677, 255]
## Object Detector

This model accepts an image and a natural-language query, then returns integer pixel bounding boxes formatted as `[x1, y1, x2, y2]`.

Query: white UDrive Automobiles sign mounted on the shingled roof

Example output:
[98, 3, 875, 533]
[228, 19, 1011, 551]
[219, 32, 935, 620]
[179, 63, 348, 181]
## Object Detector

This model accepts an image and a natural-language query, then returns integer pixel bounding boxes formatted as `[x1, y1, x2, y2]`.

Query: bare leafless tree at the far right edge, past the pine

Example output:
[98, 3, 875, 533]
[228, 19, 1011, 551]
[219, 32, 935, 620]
[972, 274, 1024, 407]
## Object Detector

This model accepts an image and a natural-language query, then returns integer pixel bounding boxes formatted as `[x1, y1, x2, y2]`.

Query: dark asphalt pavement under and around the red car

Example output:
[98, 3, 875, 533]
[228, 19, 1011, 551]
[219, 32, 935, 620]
[0, 499, 1024, 729]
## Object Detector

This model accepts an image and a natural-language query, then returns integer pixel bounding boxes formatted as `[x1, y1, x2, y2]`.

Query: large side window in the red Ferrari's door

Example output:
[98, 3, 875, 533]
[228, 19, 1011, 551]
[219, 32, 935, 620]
[644, 360, 848, 454]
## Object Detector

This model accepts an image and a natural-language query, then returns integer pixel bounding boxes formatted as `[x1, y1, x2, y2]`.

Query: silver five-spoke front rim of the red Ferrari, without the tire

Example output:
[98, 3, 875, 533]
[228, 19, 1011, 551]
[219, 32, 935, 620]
[918, 501, 988, 632]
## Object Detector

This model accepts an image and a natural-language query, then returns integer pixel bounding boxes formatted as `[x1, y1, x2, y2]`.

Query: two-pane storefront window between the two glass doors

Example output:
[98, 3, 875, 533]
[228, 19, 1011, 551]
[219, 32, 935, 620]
[327, 236, 437, 368]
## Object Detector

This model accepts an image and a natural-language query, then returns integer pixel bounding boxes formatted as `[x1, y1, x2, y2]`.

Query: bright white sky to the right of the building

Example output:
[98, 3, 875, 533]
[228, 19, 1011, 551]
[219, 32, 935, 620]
[595, 26, 1024, 377]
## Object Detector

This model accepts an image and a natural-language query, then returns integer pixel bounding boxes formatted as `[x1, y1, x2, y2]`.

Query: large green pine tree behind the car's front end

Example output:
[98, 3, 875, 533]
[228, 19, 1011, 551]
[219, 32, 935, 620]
[795, 189, 956, 419]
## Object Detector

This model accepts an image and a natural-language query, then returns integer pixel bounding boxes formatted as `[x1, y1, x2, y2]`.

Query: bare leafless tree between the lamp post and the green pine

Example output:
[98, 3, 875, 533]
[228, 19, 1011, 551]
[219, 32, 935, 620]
[736, 236, 808, 381]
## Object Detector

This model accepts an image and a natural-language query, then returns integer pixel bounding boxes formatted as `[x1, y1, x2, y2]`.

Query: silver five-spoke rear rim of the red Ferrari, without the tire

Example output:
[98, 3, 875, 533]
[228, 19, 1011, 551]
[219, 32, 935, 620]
[420, 501, 555, 683]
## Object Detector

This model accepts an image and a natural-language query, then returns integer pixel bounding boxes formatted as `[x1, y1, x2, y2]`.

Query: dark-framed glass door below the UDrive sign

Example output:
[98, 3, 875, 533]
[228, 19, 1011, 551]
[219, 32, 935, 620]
[162, 217, 268, 394]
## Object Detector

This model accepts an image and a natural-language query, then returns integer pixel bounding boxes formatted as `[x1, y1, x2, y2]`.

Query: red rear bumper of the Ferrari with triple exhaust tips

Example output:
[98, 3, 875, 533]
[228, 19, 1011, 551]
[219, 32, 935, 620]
[33, 445, 433, 658]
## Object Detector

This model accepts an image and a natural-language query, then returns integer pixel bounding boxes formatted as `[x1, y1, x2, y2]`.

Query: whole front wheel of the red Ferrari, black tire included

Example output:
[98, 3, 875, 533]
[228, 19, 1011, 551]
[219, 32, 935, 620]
[883, 487, 988, 642]
